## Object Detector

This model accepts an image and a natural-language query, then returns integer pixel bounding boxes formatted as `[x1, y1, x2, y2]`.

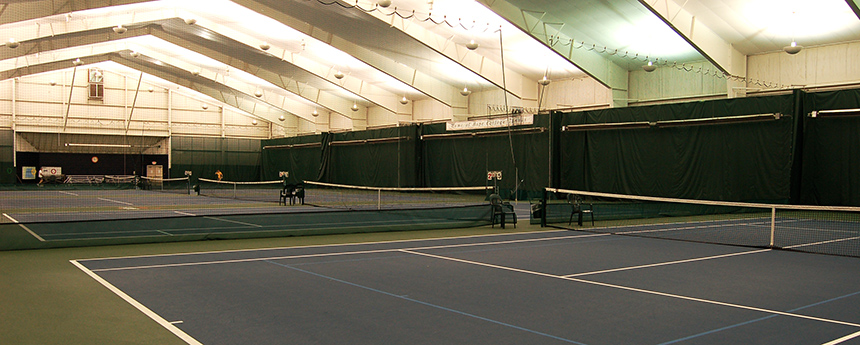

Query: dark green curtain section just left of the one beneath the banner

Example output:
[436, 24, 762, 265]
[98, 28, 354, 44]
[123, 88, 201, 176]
[320, 126, 420, 187]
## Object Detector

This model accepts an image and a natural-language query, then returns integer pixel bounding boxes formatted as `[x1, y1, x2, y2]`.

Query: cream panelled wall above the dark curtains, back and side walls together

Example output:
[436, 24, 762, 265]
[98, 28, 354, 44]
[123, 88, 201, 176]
[0, 42, 860, 139]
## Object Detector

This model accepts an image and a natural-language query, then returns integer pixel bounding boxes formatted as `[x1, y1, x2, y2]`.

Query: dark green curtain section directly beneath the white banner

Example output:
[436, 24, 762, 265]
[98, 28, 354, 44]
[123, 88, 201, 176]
[424, 115, 549, 199]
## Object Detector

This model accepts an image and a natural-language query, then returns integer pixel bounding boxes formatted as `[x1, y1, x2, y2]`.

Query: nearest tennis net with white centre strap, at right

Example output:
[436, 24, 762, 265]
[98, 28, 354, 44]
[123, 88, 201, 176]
[540, 188, 860, 257]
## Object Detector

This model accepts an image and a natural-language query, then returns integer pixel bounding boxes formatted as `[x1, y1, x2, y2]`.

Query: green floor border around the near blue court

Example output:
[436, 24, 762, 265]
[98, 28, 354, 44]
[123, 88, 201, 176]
[0, 223, 524, 345]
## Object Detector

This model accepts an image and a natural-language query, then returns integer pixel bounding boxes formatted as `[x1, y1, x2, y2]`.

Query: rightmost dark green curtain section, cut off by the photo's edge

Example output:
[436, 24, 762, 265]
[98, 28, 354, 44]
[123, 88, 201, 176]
[801, 90, 860, 206]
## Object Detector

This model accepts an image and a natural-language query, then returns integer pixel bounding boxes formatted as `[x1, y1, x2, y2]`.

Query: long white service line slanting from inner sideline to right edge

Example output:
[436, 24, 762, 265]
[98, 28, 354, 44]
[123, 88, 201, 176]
[400, 249, 860, 328]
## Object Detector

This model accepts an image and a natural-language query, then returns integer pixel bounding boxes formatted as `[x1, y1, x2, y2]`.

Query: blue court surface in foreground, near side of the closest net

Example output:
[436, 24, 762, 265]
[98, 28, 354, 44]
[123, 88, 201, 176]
[72, 231, 860, 345]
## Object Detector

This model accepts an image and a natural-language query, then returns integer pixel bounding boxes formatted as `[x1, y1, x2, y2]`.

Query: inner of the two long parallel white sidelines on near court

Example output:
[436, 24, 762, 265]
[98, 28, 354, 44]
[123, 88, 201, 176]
[87, 234, 610, 272]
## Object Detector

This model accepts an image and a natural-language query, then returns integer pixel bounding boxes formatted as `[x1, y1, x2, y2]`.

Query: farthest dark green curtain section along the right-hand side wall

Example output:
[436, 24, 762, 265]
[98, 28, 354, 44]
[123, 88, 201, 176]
[262, 135, 322, 183]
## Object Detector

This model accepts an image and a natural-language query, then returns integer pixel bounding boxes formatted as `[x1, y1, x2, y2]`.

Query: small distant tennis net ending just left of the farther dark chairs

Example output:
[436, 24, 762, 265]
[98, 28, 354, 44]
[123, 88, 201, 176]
[197, 178, 285, 203]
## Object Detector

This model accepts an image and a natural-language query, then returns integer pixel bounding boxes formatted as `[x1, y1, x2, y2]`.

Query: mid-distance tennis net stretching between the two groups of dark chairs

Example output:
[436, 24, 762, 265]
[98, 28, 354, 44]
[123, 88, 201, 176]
[303, 181, 492, 210]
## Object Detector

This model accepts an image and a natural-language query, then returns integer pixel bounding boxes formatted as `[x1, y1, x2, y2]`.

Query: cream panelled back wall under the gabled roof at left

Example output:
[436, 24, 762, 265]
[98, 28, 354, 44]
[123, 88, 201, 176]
[0, 69, 274, 139]
